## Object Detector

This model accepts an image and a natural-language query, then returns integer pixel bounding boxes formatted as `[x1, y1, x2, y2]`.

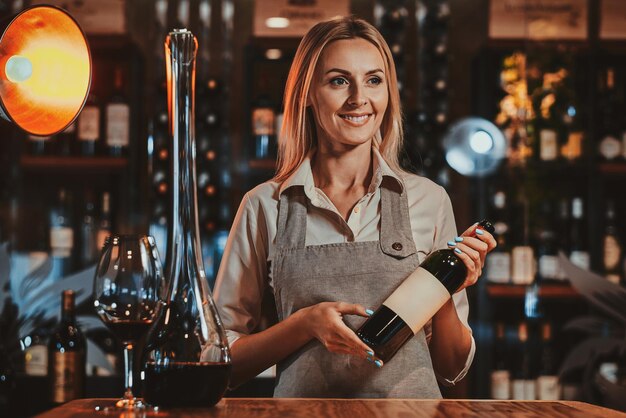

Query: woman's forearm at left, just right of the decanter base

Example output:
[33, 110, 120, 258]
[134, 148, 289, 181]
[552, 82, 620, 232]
[230, 309, 313, 387]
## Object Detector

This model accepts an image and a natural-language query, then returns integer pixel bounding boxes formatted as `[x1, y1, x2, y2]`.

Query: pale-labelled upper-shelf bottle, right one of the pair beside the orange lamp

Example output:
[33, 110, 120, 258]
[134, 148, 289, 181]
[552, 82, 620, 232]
[105, 66, 130, 157]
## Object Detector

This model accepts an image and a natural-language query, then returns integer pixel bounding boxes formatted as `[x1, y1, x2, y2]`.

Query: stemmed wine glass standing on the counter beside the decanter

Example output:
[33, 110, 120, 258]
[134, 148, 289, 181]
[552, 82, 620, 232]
[94, 235, 166, 410]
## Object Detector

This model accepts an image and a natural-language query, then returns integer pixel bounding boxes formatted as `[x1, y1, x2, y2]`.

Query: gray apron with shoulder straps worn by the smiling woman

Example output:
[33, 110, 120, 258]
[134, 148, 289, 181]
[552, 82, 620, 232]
[270, 186, 441, 398]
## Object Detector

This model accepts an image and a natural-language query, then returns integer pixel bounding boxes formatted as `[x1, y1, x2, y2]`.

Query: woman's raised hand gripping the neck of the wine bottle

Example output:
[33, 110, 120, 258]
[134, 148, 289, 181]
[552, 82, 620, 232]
[448, 224, 497, 292]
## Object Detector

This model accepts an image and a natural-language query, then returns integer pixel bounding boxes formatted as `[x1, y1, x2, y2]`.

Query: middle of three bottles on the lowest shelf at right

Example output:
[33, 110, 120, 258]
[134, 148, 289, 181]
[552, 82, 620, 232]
[511, 321, 537, 400]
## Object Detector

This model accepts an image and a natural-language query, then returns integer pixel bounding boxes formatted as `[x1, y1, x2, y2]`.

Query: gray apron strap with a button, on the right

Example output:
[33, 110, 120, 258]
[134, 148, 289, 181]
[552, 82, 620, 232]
[380, 185, 417, 258]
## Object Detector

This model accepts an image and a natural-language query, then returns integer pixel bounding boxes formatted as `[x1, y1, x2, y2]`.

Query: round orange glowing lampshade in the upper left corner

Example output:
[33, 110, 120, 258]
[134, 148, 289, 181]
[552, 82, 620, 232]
[0, 6, 91, 136]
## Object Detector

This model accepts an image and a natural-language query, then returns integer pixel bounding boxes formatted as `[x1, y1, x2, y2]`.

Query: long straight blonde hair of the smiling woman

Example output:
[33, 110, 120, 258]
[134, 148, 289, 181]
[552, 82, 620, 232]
[274, 16, 403, 182]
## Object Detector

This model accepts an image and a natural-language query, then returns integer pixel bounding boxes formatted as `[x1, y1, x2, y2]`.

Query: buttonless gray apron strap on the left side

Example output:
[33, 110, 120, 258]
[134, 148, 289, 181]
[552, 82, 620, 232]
[276, 186, 307, 251]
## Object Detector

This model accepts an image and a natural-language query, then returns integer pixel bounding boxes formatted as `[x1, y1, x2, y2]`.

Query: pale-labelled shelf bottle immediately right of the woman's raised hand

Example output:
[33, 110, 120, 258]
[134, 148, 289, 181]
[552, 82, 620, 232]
[486, 190, 511, 283]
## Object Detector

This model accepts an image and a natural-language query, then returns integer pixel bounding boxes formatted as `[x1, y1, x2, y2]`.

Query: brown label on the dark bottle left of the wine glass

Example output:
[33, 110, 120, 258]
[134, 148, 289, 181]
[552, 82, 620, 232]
[52, 351, 85, 403]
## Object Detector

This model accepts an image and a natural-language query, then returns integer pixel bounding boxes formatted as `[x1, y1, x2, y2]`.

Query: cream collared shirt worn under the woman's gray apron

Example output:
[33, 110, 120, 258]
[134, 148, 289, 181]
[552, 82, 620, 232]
[214, 148, 476, 385]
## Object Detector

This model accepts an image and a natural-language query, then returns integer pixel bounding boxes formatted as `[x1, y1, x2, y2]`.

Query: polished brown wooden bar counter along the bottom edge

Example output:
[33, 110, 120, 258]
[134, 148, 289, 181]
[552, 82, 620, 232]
[33, 398, 626, 418]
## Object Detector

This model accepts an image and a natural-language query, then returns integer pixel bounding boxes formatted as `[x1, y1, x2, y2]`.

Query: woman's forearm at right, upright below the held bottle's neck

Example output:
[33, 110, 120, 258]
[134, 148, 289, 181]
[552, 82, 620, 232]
[429, 299, 472, 380]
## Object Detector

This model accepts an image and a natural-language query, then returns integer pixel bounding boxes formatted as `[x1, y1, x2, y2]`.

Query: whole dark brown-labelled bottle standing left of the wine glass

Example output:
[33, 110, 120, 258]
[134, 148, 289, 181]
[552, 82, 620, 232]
[48, 290, 87, 404]
